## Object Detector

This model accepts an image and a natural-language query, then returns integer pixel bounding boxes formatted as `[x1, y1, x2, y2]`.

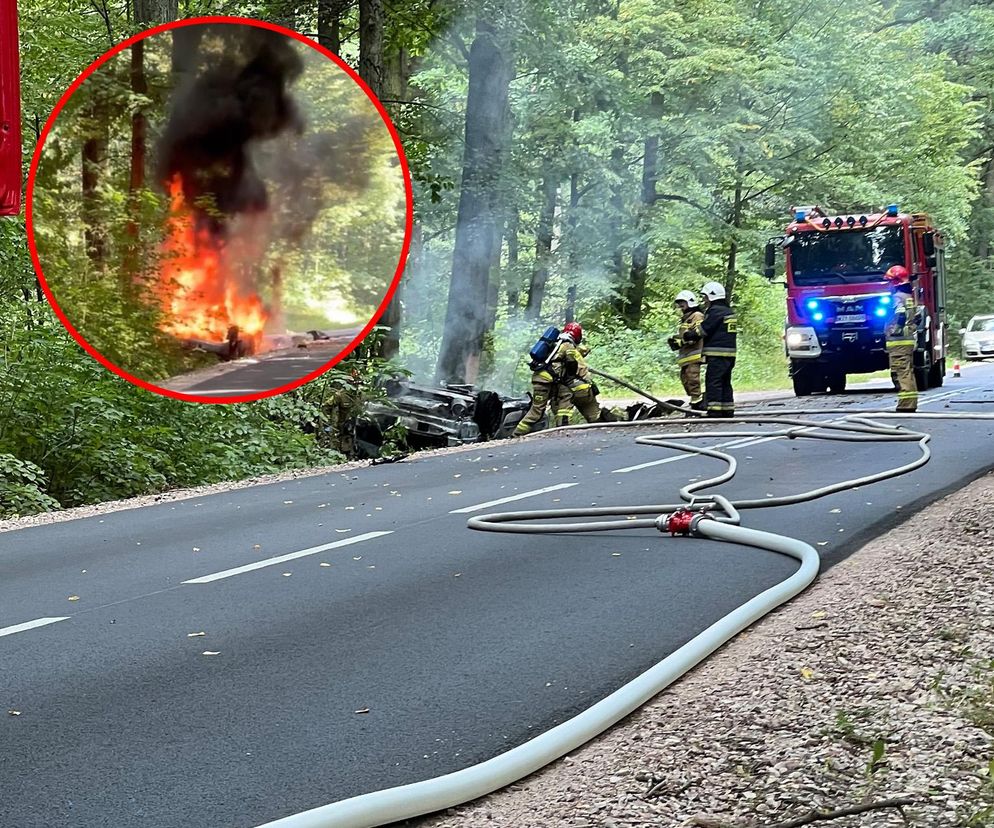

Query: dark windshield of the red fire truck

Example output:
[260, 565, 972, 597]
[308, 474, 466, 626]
[787, 225, 904, 285]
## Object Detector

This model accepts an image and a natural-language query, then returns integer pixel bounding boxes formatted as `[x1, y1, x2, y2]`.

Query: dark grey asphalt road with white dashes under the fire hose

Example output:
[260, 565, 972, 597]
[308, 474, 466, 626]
[0, 365, 994, 828]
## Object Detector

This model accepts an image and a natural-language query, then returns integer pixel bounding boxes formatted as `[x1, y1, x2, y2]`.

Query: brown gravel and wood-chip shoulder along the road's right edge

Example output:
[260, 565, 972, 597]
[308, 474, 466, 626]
[416, 474, 994, 828]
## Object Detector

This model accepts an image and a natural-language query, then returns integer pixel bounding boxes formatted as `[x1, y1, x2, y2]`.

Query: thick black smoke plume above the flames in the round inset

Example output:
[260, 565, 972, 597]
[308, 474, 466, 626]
[158, 24, 304, 235]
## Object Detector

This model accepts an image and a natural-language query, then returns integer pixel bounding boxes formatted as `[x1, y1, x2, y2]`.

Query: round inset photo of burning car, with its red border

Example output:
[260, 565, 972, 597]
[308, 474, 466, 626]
[27, 18, 412, 402]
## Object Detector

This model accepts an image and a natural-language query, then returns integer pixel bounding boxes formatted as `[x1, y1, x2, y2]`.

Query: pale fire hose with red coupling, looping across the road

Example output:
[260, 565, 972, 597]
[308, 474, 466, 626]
[260, 404, 994, 828]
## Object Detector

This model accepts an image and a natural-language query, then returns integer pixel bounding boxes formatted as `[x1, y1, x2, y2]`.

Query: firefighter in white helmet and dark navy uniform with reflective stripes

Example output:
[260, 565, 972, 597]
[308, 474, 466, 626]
[683, 282, 737, 417]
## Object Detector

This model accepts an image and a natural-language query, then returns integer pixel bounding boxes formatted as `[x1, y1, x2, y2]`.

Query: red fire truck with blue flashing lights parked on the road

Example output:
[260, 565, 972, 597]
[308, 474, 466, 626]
[765, 204, 946, 397]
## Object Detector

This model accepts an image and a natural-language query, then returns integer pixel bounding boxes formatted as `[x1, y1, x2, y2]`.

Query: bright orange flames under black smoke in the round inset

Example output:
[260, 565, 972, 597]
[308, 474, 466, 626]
[158, 175, 268, 350]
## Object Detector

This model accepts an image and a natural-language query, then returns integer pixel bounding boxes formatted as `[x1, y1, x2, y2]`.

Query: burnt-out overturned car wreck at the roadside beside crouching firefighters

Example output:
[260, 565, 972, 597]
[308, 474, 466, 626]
[355, 379, 547, 458]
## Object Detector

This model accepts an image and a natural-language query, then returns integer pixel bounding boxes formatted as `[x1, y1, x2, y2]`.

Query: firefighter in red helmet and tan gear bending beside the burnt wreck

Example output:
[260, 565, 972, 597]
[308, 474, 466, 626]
[514, 322, 601, 437]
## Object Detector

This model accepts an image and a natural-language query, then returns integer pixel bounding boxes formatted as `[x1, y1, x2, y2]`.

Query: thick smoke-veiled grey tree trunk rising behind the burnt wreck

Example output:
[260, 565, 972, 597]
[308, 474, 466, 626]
[436, 20, 514, 382]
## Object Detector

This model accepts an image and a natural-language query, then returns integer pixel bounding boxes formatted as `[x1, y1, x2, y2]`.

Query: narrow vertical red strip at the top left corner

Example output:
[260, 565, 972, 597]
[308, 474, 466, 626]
[0, 0, 21, 216]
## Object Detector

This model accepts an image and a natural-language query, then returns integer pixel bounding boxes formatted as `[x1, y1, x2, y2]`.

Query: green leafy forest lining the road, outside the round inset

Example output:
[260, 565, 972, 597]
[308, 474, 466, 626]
[0, 0, 994, 514]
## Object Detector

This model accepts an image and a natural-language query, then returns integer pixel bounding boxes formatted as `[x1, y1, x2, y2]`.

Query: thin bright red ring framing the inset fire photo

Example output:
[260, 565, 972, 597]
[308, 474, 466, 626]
[25, 16, 414, 403]
